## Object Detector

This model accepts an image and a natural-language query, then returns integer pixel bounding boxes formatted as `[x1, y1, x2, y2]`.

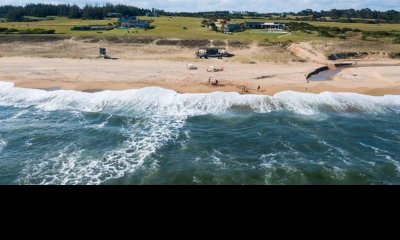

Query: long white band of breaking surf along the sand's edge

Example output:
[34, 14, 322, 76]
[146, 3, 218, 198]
[0, 82, 400, 116]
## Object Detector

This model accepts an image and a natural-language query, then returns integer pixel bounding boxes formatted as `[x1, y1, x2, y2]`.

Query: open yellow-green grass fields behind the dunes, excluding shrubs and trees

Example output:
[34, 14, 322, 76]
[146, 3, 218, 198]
[0, 17, 400, 42]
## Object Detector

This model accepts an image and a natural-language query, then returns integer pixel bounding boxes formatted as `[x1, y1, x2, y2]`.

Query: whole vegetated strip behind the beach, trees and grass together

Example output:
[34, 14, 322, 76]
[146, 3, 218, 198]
[0, 4, 400, 48]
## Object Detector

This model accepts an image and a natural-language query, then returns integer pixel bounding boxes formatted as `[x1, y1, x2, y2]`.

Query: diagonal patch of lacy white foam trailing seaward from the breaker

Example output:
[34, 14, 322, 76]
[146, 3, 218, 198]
[19, 115, 184, 185]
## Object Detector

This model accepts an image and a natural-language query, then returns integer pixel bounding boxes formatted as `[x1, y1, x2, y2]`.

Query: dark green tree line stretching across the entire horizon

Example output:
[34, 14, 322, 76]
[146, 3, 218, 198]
[0, 4, 400, 22]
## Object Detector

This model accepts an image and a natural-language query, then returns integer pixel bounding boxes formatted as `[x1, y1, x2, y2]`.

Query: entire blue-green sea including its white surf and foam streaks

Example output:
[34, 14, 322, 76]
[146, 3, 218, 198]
[0, 82, 400, 184]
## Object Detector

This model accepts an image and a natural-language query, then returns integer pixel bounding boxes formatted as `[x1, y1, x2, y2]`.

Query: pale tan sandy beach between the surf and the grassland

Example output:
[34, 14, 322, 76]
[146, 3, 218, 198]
[0, 41, 400, 96]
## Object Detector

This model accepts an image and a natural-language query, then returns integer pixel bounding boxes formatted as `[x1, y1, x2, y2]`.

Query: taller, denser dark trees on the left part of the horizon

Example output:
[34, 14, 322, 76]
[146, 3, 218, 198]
[0, 4, 163, 21]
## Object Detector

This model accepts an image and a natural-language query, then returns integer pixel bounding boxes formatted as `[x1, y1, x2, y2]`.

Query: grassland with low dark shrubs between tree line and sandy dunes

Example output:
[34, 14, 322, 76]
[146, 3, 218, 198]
[0, 16, 400, 43]
